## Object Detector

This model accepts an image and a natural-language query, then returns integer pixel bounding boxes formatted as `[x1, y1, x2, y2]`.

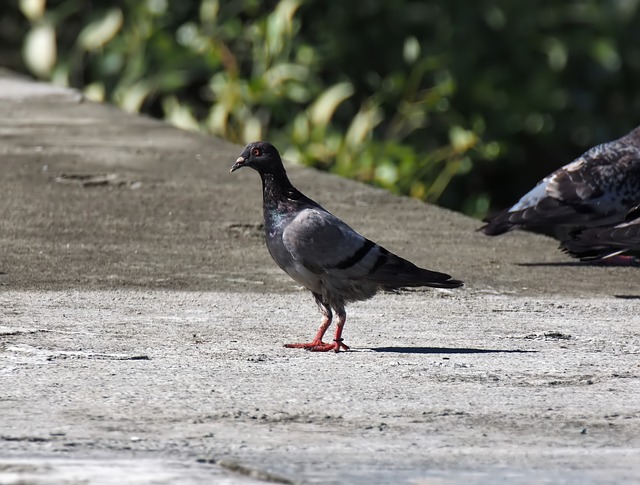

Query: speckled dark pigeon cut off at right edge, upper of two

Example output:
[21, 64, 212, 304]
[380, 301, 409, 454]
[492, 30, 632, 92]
[479, 126, 640, 240]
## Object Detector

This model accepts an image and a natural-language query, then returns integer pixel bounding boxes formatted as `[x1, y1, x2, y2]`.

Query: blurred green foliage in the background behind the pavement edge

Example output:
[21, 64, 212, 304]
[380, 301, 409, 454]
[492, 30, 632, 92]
[0, 0, 640, 216]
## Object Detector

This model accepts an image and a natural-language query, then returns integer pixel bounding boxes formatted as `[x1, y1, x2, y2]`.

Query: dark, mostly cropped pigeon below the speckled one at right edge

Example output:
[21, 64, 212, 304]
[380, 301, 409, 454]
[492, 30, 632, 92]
[560, 204, 640, 261]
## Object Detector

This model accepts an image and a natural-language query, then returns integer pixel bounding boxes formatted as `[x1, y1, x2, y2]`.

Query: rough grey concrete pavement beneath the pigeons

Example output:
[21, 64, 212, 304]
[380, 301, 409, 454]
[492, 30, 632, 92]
[0, 72, 640, 483]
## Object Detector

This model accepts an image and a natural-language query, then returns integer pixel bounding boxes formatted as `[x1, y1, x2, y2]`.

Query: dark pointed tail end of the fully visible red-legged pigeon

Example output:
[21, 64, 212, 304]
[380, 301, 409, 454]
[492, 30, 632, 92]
[368, 253, 464, 289]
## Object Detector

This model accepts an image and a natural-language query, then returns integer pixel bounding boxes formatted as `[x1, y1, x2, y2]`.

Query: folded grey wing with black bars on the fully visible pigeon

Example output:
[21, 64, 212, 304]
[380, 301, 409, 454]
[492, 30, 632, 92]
[282, 208, 462, 288]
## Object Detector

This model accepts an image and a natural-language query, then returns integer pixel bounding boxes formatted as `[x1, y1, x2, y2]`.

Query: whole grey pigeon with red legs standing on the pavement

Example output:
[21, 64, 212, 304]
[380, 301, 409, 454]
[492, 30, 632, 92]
[231, 141, 463, 352]
